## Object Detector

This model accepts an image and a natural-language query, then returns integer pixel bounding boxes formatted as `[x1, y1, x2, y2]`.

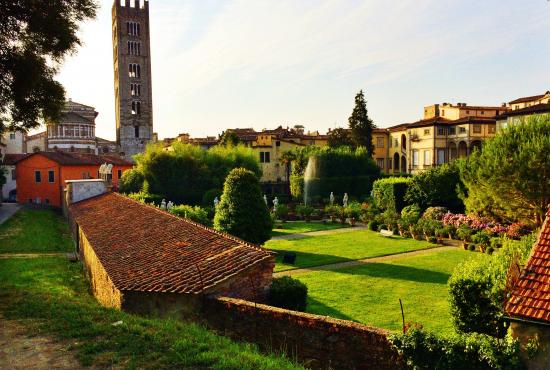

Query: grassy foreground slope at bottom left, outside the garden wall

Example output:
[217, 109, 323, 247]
[0, 258, 301, 369]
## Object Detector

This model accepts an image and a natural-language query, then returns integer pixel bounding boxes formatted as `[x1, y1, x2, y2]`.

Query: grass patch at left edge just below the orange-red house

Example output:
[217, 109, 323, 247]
[0, 208, 74, 253]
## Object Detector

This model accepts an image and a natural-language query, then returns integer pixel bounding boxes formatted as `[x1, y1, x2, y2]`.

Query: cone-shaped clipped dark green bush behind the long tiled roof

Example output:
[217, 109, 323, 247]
[214, 168, 273, 244]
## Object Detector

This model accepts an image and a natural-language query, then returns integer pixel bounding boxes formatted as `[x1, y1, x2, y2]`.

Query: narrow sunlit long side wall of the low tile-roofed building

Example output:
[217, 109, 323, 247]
[77, 228, 122, 309]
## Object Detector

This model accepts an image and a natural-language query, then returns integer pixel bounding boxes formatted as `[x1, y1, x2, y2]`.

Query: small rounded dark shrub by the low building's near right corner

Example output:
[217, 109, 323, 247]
[268, 276, 307, 311]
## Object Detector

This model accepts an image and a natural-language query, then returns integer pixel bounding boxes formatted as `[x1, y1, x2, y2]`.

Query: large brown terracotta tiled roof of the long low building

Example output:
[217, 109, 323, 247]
[70, 193, 273, 293]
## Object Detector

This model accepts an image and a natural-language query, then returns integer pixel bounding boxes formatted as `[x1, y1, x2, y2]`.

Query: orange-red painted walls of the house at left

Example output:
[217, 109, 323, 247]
[16, 154, 132, 207]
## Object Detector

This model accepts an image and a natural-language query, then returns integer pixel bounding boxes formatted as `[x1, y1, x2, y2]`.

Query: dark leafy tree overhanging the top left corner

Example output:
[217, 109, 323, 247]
[0, 0, 97, 134]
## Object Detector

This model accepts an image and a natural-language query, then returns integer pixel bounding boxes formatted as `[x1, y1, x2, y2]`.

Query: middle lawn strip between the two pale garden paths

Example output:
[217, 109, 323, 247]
[265, 230, 435, 272]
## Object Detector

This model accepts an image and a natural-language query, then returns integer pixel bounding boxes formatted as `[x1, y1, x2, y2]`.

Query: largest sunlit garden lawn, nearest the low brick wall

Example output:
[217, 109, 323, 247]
[297, 249, 484, 333]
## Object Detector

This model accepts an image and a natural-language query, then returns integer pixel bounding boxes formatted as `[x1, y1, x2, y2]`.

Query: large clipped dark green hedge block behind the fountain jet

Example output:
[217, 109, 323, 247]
[290, 147, 380, 202]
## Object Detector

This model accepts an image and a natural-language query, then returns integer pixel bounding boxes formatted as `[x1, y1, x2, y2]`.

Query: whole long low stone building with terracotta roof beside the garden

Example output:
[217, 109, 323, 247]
[66, 180, 275, 317]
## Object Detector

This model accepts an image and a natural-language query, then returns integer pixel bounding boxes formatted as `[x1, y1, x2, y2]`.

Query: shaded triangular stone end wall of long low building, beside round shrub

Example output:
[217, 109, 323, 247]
[211, 257, 275, 302]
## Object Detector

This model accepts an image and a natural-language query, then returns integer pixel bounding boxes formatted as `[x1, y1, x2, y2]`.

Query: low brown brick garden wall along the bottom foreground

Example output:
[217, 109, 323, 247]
[202, 297, 403, 370]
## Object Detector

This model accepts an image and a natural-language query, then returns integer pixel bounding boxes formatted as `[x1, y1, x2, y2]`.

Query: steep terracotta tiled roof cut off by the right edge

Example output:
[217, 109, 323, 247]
[506, 211, 550, 323]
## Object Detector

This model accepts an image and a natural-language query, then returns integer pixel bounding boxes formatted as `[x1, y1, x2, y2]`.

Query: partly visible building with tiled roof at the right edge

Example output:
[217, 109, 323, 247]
[506, 210, 550, 370]
